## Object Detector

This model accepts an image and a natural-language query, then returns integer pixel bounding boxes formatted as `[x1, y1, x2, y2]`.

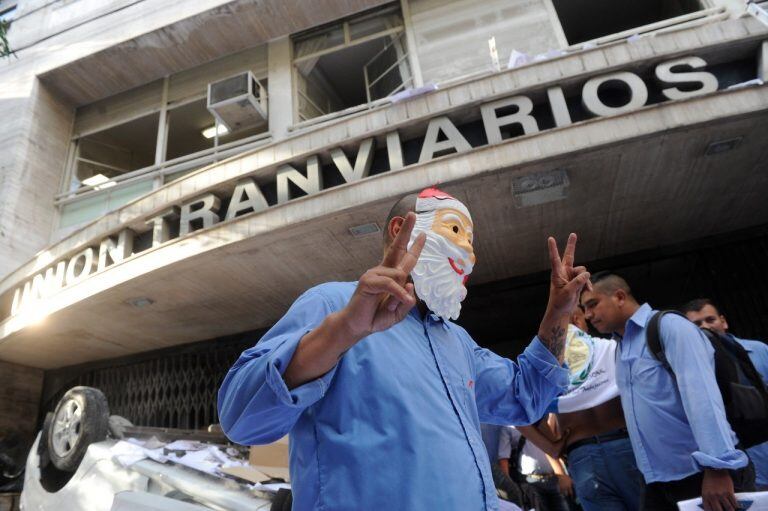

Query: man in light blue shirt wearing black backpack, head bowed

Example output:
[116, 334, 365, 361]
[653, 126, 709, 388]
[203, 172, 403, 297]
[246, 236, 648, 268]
[581, 272, 754, 511]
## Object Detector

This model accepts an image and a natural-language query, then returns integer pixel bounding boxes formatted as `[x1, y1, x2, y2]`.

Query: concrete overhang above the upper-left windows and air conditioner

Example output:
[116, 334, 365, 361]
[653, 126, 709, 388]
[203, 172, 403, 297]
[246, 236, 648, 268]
[40, 0, 389, 106]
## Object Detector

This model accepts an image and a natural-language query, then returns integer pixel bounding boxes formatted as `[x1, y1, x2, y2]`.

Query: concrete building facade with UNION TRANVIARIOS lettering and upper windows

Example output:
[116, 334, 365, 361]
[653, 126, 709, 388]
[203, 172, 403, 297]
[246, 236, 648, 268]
[0, 0, 768, 440]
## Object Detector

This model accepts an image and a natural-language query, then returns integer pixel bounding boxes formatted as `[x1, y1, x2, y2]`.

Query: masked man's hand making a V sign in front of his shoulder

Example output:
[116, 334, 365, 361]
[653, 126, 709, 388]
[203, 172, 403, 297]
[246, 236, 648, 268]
[340, 213, 426, 340]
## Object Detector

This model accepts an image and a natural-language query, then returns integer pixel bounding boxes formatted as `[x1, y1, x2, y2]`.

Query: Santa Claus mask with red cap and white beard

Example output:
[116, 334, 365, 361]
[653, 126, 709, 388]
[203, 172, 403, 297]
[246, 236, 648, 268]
[409, 188, 475, 319]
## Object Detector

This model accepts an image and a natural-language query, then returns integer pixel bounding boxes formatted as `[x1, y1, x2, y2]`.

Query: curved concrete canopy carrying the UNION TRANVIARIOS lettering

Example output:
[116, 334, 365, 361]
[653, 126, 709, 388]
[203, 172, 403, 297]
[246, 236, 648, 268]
[0, 18, 768, 368]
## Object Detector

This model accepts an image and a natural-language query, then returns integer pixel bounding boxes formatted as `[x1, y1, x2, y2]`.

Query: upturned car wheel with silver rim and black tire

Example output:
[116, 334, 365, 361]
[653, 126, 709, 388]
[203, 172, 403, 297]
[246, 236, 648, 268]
[47, 387, 109, 472]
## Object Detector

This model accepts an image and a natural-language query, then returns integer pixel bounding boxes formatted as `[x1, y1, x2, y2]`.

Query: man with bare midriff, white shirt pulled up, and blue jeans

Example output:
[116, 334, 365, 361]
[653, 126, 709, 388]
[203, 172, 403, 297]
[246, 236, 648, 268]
[518, 307, 643, 511]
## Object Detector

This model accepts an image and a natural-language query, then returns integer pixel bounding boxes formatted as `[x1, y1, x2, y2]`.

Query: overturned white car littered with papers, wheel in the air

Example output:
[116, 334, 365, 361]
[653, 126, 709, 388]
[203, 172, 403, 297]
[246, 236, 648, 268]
[21, 387, 291, 511]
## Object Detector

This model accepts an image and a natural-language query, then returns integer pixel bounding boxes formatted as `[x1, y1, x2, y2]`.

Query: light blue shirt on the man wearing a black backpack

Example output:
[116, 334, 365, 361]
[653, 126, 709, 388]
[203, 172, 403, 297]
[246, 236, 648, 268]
[616, 304, 749, 483]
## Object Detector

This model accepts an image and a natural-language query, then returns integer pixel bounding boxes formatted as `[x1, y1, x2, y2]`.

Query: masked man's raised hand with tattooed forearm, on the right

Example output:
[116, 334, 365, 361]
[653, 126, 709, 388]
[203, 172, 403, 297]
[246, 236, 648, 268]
[539, 233, 592, 363]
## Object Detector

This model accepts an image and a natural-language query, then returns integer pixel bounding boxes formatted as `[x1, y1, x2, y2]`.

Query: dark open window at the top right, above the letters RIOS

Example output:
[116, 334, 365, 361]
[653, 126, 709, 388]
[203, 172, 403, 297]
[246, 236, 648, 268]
[552, 0, 702, 44]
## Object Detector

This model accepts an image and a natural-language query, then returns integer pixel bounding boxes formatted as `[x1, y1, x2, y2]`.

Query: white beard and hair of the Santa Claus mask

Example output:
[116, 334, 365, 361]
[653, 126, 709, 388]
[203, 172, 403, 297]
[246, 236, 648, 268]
[411, 224, 472, 320]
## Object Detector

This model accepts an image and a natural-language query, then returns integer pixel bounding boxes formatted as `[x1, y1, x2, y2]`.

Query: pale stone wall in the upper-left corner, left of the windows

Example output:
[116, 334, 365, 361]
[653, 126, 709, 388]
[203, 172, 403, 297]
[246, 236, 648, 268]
[0, 0, 240, 275]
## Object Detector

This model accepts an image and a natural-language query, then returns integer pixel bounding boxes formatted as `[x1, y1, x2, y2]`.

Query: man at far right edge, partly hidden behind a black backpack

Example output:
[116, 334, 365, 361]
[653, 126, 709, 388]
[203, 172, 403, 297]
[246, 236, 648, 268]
[680, 298, 768, 491]
